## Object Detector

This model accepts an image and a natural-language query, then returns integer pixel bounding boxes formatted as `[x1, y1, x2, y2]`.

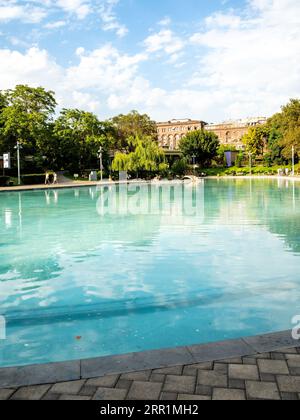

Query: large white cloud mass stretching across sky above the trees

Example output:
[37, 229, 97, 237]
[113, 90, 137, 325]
[0, 0, 300, 121]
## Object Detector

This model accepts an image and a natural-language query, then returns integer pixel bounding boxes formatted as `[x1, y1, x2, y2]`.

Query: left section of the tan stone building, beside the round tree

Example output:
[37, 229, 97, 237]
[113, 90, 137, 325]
[157, 119, 206, 151]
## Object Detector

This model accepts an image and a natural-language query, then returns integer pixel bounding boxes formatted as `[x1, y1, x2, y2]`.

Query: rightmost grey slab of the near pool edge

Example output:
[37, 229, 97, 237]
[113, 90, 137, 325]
[243, 330, 300, 353]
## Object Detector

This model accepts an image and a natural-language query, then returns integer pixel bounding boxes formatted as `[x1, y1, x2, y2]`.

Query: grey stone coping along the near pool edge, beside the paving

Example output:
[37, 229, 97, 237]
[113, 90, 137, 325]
[0, 330, 300, 388]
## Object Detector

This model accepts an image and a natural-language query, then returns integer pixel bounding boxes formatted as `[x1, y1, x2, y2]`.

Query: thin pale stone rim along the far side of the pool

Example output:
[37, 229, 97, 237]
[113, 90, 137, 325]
[0, 175, 300, 193]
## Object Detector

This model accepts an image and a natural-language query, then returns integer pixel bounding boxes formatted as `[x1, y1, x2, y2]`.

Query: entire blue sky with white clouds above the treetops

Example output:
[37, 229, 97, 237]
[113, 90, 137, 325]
[0, 0, 300, 122]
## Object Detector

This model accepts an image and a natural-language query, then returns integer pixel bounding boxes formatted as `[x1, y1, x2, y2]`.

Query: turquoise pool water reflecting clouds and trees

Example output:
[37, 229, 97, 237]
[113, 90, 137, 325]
[0, 180, 300, 366]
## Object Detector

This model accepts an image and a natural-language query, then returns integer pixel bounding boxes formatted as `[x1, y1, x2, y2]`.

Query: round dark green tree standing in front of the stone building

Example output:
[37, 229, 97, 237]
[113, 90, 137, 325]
[179, 130, 220, 167]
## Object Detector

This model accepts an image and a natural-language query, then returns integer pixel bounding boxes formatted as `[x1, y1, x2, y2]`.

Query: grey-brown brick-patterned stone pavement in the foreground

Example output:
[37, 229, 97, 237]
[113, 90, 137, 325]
[0, 347, 300, 401]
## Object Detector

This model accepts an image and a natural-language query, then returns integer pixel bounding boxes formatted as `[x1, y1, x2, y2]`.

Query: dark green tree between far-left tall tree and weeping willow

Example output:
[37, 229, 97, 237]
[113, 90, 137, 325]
[52, 109, 111, 173]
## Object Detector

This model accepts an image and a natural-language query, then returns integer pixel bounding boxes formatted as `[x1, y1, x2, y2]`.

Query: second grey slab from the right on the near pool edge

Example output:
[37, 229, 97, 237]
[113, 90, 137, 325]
[188, 340, 255, 363]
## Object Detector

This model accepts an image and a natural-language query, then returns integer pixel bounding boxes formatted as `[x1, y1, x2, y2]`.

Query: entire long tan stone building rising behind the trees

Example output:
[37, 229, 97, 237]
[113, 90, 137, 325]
[157, 117, 267, 151]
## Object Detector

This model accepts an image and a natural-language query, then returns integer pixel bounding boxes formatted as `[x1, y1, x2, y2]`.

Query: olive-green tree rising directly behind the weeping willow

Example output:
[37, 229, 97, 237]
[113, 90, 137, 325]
[110, 111, 157, 152]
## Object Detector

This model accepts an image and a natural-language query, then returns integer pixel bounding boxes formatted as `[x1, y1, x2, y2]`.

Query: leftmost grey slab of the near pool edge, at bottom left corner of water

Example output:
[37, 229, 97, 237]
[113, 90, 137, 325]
[0, 361, 80, 388]
